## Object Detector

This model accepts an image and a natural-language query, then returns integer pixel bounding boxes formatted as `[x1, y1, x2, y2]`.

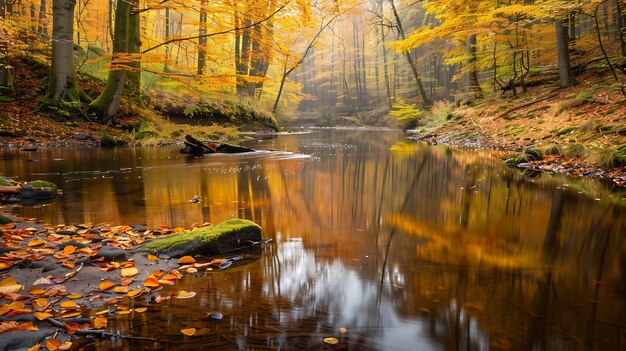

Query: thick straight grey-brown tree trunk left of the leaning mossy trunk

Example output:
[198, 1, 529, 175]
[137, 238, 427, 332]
[46, 0, 89, 105]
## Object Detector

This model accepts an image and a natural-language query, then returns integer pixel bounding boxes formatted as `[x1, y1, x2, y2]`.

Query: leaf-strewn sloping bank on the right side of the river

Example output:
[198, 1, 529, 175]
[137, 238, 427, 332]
[414, 65, 626, 187]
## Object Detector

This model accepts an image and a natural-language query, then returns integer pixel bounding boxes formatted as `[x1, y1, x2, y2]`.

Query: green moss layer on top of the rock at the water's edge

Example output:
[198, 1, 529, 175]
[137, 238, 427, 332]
[140, 218, 261, 252]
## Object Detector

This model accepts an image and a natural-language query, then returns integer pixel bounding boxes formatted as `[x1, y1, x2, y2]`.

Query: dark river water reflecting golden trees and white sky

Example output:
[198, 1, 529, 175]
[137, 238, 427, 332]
[0, 130, 626, 350]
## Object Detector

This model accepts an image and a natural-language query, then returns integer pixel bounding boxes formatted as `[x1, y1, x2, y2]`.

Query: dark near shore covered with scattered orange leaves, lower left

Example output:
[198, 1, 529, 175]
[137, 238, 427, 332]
[0, 213, 258, 350]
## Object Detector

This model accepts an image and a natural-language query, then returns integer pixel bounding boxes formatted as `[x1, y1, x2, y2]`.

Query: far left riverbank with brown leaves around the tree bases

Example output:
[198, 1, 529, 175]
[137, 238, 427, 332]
[0, 57, 277, 148]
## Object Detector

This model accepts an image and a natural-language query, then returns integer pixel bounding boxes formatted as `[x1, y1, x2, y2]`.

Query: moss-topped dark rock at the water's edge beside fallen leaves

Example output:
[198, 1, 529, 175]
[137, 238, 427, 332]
[138, 219, 261, 257]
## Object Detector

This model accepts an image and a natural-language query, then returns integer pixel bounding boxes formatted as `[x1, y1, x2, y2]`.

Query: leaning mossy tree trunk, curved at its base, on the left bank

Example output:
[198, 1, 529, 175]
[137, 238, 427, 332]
[89, 0, 135, 124]
